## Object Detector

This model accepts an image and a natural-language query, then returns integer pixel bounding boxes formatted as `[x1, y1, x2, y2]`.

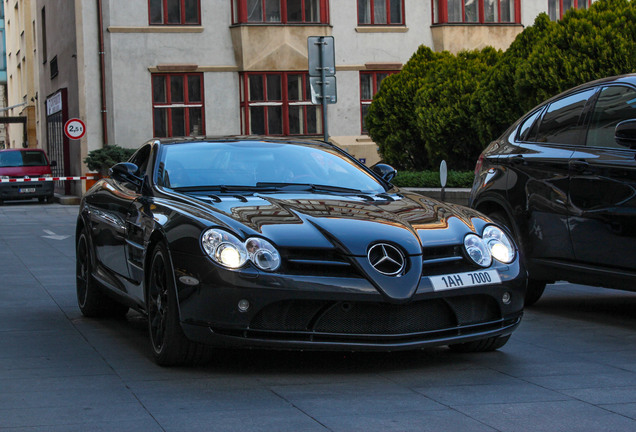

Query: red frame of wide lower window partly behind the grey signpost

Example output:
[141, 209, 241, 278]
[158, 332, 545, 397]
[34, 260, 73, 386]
[240, 71, 324, 136]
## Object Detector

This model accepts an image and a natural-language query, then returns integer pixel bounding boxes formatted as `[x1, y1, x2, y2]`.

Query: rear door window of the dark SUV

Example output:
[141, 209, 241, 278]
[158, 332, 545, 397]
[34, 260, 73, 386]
[535, 88, 596, 144]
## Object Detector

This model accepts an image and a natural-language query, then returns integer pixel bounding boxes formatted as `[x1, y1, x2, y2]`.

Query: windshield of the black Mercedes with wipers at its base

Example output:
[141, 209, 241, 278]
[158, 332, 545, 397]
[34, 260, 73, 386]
[157, 141, 385, 193]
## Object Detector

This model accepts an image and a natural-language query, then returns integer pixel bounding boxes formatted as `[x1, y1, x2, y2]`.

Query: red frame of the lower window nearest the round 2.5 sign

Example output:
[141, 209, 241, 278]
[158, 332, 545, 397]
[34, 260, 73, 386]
[150, 72, 205, 138]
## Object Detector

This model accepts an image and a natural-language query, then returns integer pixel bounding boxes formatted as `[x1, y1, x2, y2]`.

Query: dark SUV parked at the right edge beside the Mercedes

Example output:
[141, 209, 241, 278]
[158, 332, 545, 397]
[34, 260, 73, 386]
[470, 74, 636, 305]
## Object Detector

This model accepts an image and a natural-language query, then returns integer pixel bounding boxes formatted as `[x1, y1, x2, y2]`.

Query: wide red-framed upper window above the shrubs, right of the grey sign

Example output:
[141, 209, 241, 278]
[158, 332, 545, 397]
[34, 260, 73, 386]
[433, 0, 521, 24]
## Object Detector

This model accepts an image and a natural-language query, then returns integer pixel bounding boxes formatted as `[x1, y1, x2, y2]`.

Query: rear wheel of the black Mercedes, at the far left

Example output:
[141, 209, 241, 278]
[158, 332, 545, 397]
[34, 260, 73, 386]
[75, 230, 128, 318]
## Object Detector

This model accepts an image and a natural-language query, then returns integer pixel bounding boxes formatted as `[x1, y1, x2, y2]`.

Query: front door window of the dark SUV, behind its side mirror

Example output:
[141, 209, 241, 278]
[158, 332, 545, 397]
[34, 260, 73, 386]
[586, 86, 636, 148]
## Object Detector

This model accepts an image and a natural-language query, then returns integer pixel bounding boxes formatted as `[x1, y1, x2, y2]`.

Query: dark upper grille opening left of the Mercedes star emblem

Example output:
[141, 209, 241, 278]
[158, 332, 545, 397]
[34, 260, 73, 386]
[280, 248, 362, 277]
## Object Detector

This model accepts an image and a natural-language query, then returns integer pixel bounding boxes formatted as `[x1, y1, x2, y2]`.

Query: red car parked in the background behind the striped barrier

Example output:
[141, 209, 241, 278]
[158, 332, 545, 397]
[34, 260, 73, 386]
[0, 149, 55, 204]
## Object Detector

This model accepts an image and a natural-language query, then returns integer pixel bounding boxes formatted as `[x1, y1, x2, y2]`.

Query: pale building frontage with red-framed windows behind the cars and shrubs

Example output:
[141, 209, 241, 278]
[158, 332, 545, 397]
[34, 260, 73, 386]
[6, 0, 587, 195]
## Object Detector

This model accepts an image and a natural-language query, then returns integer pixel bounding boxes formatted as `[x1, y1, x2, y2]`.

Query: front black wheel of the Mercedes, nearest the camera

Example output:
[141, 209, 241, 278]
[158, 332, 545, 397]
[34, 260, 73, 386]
[146, 243, 209, 366]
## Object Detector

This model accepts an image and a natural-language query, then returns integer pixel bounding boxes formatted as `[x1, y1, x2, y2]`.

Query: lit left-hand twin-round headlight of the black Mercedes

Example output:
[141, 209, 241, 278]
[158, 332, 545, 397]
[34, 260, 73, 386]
[201, 229, 281, 271]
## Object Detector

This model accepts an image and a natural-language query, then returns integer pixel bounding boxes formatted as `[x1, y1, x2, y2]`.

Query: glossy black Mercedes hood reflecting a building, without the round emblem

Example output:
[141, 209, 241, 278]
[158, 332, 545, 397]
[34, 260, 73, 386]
[176, 192, 488, 301]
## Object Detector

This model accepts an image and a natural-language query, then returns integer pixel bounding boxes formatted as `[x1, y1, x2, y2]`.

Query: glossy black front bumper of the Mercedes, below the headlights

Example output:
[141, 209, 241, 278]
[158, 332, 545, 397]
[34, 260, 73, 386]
[172, 253, 526, 351]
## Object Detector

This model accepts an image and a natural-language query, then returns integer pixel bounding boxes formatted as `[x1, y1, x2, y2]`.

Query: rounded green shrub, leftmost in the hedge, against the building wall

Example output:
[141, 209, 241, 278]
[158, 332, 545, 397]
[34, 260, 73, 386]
[366, 46, 501, 170]
